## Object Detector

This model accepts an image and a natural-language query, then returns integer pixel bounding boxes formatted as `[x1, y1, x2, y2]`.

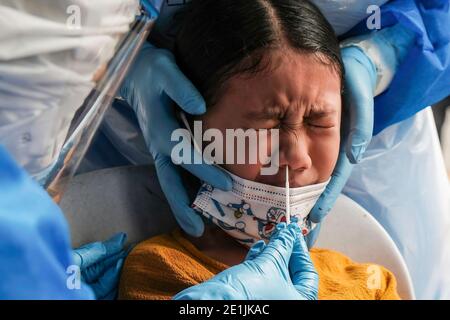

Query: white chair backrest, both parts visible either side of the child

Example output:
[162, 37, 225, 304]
[60, 166, 414, 299]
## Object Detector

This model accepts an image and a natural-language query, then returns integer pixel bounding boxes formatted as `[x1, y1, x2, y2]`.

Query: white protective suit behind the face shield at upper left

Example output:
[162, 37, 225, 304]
[0, 0, 139, 179]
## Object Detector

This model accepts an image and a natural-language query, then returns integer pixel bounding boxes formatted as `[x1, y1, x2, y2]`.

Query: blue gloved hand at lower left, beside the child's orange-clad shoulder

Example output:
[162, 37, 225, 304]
[73, 233, 128, 300]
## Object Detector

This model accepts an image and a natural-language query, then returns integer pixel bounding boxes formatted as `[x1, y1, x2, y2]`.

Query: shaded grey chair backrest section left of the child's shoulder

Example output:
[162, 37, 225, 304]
[60, 166, 176, 247]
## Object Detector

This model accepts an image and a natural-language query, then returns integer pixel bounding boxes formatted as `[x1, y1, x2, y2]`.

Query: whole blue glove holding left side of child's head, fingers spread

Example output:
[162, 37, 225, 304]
[120, 43, 232, 236]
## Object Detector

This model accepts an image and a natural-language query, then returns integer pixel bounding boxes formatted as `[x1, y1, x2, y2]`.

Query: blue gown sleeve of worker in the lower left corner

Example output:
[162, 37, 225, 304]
[0, 146, 94, 299]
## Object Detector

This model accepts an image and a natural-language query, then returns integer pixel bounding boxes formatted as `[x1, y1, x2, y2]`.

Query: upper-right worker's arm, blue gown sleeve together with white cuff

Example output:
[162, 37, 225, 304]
[347, 0, 450, 134]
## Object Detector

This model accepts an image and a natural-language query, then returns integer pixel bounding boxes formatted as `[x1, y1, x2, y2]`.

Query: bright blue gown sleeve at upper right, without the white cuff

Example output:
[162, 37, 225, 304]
[345, 0, 450, 134]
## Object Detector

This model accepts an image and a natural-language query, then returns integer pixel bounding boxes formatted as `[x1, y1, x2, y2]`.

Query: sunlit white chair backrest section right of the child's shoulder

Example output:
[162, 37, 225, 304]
[316, 195, 415, 300]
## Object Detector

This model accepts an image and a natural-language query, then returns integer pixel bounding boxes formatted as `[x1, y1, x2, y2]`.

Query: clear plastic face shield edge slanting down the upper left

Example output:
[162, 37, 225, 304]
[36, 3, 160, 202]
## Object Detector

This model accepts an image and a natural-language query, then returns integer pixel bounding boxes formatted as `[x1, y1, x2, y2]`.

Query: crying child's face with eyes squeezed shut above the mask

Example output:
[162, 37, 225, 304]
[201, 51, 341, 187]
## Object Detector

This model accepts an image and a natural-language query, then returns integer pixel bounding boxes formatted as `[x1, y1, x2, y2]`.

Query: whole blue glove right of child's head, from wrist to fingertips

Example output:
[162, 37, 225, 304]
[308, 25, 414, 247]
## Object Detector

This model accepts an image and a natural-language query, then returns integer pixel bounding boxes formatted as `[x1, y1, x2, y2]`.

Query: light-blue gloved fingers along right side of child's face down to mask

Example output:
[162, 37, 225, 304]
[308, 47, 377, 247]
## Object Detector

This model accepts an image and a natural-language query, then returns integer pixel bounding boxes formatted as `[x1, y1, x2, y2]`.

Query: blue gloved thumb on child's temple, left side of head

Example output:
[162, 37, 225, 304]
[154, 49, 206, 115]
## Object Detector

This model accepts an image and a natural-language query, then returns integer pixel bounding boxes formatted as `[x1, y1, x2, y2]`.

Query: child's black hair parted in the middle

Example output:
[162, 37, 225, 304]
[174, 0, 344, 105]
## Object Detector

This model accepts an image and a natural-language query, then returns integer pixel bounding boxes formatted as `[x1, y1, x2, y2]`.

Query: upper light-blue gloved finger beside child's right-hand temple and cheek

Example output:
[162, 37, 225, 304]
[342, 47, 376, 163]
